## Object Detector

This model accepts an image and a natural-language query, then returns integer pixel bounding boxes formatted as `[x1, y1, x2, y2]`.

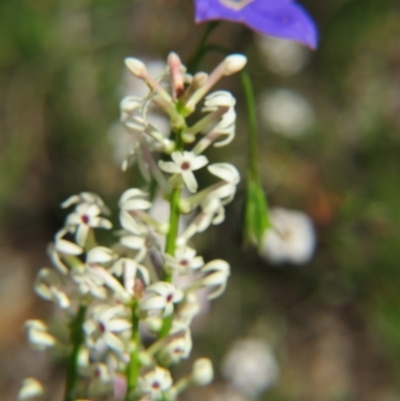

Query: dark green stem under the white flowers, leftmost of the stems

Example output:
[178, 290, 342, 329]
[64, 305, 86, 401]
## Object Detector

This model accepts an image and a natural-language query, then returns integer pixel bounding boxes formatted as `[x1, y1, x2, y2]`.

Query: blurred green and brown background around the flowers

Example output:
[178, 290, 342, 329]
[0, 0, 400, 401]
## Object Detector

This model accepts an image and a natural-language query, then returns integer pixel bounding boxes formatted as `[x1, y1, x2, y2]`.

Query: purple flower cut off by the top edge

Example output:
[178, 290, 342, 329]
[195, 0, 318, 49]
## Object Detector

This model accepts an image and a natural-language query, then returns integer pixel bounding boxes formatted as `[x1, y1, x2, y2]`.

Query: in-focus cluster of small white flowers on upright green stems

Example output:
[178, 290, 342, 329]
[19, 53, 246, 401]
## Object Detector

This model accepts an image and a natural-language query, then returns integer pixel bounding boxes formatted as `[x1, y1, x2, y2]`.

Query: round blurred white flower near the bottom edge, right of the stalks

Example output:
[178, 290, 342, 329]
[222, 339, 279, 398]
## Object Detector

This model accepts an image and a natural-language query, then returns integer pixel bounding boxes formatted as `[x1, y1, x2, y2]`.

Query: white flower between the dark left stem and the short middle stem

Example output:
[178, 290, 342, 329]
[83, 305, 132, 354]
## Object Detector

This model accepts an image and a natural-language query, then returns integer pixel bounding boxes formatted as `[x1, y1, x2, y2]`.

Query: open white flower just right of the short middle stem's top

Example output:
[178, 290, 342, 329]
[139, 281, 183, 317]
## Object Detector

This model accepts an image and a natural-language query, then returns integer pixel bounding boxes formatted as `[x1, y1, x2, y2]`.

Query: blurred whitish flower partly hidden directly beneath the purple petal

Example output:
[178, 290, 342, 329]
[257, 35, 310, 76]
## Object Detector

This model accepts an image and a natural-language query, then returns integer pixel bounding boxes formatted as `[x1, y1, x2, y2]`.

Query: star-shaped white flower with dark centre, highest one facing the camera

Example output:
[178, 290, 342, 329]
[158, 151, 208, 192]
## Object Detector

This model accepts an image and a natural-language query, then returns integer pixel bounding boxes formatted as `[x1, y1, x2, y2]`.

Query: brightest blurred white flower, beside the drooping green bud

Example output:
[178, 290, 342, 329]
[260, 207, 316, 264]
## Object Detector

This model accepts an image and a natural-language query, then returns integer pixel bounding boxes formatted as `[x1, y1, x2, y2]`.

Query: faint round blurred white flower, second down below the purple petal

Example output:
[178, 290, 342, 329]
[259, 89, 315, 138]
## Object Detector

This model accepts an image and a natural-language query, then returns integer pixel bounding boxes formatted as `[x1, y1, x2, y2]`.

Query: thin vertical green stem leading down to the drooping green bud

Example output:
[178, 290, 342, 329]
[241, 68, 260, 182]
